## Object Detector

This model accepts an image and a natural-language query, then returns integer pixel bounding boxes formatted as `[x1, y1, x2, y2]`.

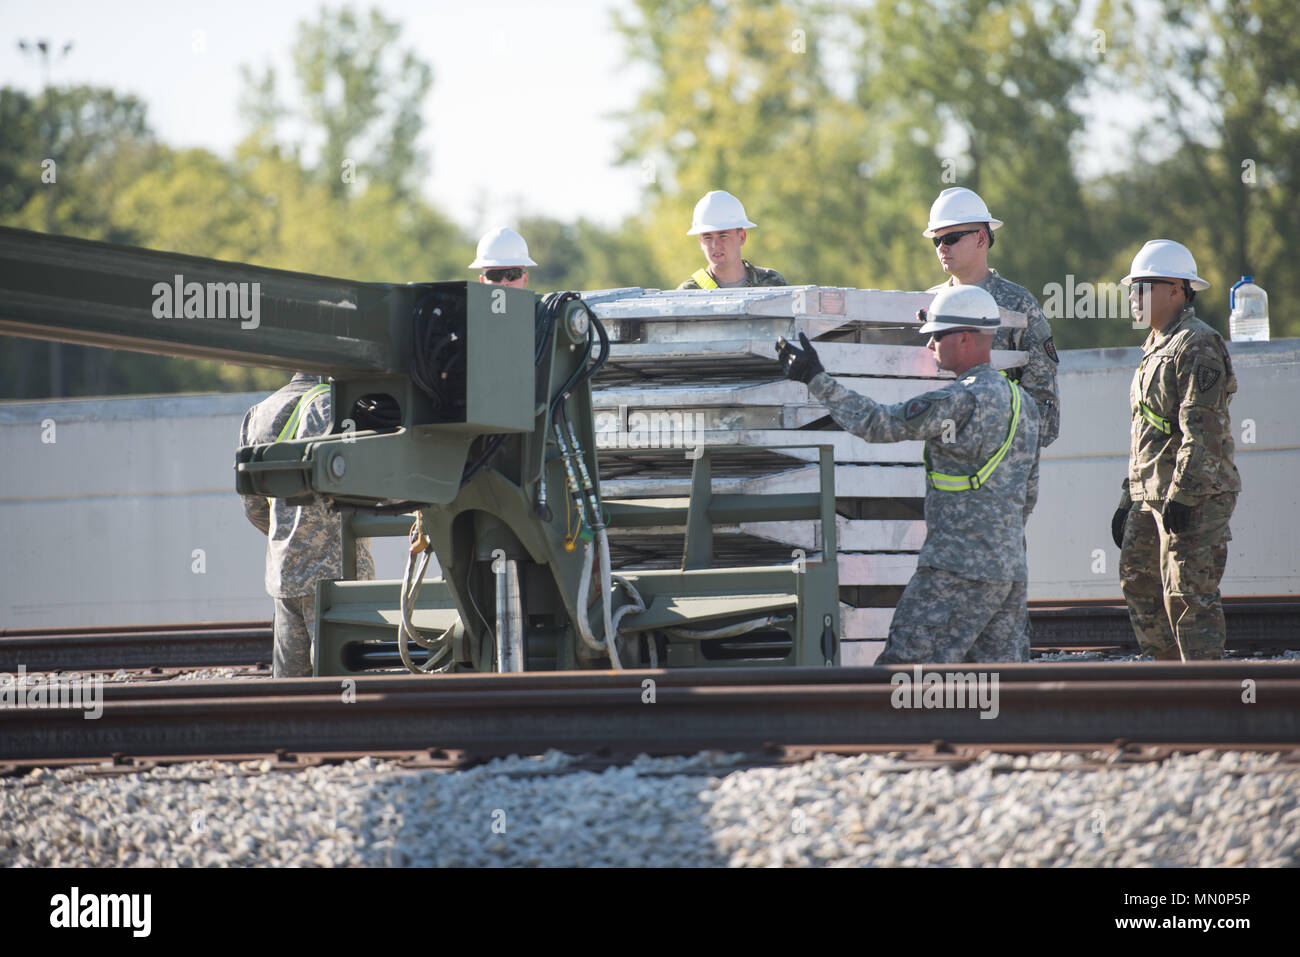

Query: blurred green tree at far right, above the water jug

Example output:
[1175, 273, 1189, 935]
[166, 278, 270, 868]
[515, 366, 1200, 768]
[1097, 0, 1300, 337]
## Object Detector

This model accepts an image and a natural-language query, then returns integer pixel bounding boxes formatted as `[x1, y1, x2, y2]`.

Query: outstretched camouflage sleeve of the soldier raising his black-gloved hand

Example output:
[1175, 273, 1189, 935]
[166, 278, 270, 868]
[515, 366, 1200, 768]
[809, 372, 975, 442]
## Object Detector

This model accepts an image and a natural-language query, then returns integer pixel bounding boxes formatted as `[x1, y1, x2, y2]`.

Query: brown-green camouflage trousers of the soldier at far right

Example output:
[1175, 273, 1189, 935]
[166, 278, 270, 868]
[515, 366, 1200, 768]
[1119, 492, 1236, 662]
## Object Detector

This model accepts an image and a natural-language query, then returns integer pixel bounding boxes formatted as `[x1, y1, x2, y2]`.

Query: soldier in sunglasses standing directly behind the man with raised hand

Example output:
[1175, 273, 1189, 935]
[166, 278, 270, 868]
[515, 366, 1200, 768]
[924, 187, 1061, 449]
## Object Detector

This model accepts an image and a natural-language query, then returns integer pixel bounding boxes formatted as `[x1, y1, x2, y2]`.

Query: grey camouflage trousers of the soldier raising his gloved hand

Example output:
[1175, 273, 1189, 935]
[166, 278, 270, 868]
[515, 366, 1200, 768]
[876, 566, 1030, 664]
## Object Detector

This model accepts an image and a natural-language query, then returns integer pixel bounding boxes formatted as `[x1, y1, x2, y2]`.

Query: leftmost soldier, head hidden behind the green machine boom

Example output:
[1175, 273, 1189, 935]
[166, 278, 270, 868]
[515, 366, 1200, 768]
[239, 372, 374, 677]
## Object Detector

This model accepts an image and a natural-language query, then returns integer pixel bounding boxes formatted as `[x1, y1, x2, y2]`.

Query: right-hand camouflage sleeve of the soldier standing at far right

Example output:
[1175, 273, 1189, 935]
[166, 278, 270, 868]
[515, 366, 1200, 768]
[1169, 338, 1231, 506]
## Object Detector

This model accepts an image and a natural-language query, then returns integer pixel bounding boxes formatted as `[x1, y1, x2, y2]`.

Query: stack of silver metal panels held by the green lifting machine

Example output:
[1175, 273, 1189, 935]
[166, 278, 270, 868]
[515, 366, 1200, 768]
[582, 286, 1026, 664]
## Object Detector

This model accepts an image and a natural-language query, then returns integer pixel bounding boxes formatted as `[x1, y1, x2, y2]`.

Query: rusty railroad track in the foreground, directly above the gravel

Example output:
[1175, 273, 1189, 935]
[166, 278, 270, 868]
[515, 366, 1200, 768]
[0, 662, 1300, 766]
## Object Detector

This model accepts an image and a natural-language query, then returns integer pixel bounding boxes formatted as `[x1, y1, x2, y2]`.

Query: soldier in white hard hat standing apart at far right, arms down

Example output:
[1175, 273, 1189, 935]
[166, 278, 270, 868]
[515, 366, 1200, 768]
[1110, 239, 1242, 662]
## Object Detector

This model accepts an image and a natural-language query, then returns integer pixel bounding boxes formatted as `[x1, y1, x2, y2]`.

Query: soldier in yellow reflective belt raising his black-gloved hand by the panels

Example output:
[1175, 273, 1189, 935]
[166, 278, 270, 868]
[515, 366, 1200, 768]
[777, 286, 1039, 664]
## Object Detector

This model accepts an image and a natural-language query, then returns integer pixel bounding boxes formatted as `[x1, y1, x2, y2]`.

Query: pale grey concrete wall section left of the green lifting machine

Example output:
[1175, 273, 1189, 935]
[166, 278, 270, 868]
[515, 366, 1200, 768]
[0, 393, 404, 628]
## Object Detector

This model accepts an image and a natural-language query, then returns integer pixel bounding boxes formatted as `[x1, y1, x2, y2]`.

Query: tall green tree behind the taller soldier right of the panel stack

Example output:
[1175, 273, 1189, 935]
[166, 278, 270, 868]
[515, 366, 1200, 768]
[854, 0, 1099, 345]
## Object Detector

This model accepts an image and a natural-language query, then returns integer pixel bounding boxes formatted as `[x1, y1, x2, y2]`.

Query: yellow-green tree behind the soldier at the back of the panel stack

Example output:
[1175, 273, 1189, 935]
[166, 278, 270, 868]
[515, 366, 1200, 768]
[616, 0, 837, 286]
